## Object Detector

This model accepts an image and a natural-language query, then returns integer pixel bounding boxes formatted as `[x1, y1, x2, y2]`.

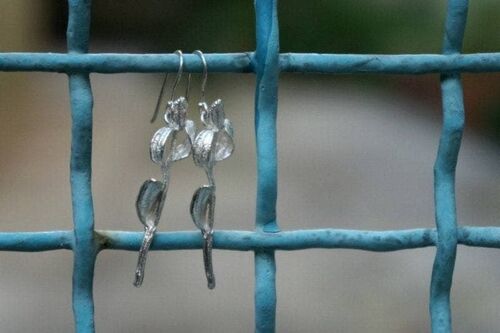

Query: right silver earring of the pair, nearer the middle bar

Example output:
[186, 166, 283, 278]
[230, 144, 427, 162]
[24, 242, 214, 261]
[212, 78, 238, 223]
[190, 50, 234, 289]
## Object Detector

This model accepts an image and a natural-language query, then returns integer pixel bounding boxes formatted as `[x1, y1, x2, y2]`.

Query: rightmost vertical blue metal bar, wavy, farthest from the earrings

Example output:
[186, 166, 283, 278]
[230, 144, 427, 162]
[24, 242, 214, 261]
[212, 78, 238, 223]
[430, 0, 468, 333]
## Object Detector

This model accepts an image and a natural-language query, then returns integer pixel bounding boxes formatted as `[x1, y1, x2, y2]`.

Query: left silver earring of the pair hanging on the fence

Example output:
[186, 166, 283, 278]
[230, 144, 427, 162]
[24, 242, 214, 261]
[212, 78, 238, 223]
[134, 50, 196, 287]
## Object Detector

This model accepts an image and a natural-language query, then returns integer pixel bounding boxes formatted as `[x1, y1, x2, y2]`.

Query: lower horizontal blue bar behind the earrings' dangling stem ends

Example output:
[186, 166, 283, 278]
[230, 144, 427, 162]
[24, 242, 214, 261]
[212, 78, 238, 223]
[0, 227, 500, 252]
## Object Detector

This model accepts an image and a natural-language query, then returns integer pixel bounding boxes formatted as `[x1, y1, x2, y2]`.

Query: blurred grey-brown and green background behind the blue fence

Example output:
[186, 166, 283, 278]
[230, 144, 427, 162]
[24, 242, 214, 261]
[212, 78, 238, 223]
[0, 0, 500, 332]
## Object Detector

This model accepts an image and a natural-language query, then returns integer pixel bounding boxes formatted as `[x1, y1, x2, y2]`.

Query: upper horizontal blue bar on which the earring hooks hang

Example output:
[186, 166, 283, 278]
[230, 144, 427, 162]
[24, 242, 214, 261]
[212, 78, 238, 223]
[0, 52, 500, 74]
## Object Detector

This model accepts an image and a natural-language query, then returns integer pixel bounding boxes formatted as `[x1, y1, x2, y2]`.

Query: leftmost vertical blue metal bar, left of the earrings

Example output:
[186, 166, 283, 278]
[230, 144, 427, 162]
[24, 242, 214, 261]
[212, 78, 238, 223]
[67, 0, 97, 333]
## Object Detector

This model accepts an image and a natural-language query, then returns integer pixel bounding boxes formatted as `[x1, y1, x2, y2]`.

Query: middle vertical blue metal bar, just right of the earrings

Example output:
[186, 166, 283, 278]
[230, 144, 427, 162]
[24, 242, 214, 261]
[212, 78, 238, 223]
[254, 0, 279, 333]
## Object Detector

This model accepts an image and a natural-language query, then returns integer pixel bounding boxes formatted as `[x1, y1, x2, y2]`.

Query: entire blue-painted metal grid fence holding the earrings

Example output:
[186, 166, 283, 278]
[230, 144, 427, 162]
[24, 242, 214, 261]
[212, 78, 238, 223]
[0, 0, 500, 333]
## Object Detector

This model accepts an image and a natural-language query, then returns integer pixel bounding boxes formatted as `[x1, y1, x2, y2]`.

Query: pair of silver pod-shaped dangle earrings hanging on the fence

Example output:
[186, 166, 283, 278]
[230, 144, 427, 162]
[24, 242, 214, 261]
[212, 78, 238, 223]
[134, 50, 234, 289]
